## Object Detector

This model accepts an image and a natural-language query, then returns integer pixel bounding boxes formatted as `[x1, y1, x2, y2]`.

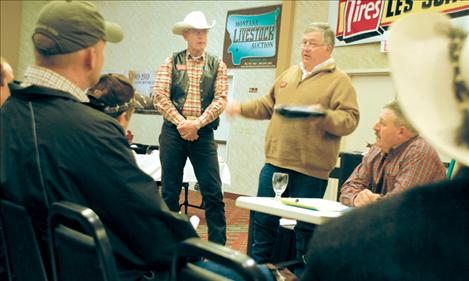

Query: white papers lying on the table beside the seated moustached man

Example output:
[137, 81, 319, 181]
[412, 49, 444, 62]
[280, 198, 350, 212]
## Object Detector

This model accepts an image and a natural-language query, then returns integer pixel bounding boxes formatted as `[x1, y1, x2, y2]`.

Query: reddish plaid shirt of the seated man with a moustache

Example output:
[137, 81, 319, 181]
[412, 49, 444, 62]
[340, 137, 445, 206]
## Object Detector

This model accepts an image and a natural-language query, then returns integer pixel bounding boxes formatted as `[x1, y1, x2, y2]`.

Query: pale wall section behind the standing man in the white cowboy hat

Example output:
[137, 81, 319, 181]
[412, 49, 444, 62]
[97, 1, 281, 194]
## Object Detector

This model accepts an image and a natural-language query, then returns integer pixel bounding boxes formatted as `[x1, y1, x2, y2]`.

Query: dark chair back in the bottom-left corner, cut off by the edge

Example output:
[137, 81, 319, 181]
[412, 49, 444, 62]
[0, 199, 47, 281]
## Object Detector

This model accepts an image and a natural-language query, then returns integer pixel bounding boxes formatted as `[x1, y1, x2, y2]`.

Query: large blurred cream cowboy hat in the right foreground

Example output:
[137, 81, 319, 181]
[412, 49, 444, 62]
[389, 13, 469, 166]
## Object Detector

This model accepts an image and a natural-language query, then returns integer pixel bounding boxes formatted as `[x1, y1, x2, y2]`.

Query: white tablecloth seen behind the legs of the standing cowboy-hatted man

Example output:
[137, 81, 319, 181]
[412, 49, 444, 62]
[134, 150, 231, 185]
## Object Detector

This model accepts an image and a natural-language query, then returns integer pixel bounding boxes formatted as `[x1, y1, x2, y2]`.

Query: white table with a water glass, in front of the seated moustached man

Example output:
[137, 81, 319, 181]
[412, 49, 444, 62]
[236, 196, 343, 224]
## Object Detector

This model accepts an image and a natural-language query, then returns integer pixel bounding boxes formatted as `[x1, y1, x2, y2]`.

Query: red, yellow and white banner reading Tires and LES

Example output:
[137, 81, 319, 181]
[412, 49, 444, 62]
[329, 0, 469, 46]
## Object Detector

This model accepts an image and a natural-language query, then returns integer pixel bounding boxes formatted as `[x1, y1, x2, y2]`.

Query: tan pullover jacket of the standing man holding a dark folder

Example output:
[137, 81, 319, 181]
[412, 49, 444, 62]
[241, 63, 359, 179]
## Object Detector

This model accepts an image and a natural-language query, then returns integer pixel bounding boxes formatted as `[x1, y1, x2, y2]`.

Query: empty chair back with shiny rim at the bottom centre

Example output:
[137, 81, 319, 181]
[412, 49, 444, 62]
[171, 238, 265, 281]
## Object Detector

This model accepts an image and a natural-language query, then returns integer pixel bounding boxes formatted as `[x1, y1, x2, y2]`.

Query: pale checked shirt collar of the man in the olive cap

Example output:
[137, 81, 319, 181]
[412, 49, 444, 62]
[21, 65, 90, 102]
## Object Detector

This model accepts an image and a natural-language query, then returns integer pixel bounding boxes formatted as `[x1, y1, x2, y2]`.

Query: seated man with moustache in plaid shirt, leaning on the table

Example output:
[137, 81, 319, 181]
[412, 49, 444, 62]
[340, 101, 445, 207]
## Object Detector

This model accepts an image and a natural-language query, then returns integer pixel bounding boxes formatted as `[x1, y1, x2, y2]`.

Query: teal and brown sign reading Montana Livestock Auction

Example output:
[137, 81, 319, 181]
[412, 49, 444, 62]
[223, 5, 282, 68]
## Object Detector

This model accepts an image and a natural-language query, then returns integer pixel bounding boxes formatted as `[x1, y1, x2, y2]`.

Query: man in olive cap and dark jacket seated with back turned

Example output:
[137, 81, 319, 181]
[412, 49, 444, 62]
[0, 1, 197, 280]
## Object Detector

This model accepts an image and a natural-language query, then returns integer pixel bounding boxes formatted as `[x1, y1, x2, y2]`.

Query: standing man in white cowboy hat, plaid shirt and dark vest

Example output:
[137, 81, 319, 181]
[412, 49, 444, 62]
[154, 11, 228, 245]
